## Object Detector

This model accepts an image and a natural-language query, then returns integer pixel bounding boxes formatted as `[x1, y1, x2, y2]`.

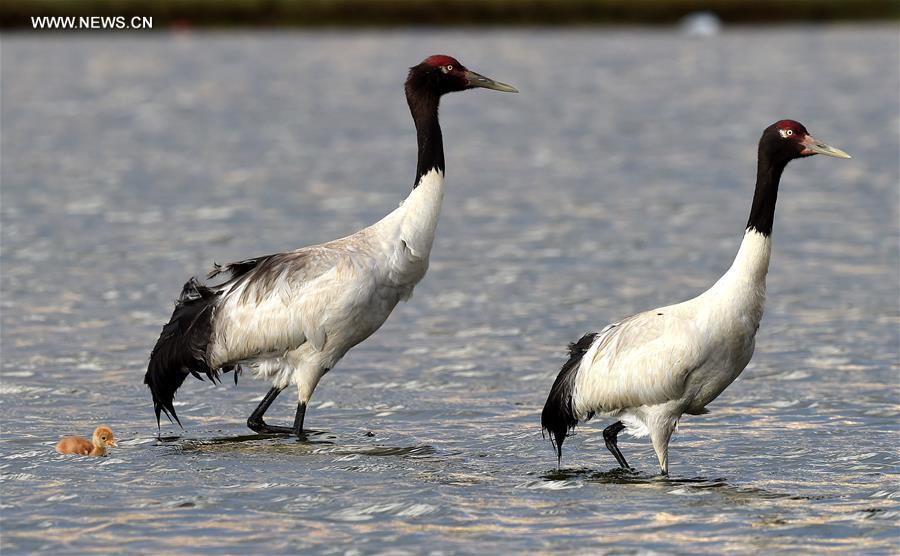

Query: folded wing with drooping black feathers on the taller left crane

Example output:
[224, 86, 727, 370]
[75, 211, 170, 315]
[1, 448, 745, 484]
[144, 246, 352, 424]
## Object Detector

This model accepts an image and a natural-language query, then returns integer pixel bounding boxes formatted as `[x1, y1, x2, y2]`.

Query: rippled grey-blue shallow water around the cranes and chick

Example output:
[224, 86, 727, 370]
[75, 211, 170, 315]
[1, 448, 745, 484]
[0, 27, 900, 554]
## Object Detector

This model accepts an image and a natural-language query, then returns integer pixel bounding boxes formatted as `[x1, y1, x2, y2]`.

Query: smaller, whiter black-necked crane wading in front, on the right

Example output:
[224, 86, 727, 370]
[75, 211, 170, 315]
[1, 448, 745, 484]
[541, 120, 850, 475]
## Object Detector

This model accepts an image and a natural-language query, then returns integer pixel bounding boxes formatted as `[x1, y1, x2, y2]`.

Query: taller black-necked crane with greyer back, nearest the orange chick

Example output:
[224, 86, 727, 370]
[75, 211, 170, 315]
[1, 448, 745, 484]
[144, 55, 517, 437]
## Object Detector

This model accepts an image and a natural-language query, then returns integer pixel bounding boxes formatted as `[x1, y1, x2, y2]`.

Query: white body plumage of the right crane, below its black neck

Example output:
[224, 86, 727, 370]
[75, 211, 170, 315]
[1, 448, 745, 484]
[573, 230, 770, 471]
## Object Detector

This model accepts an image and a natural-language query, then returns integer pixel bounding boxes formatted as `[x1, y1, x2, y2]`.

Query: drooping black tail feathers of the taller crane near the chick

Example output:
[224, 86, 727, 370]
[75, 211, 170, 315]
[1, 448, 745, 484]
[144, 278, 219, 426]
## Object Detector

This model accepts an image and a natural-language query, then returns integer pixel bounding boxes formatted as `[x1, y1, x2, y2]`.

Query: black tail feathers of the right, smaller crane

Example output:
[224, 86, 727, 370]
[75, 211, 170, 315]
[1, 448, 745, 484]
[541, 332, 597, 462]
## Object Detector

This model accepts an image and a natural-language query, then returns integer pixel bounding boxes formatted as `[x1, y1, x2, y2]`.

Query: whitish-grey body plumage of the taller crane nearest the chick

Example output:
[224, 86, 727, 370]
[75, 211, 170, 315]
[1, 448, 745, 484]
[208, 170, 444, 396]
